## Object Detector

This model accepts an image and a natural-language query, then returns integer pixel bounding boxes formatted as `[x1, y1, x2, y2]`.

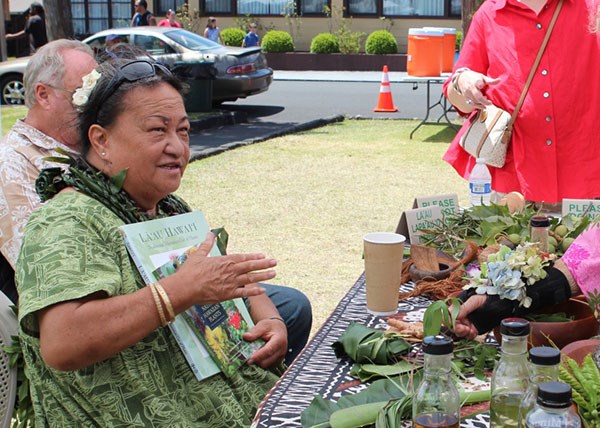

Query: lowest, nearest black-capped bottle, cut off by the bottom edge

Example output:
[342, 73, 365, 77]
[525, 382, 581, 428]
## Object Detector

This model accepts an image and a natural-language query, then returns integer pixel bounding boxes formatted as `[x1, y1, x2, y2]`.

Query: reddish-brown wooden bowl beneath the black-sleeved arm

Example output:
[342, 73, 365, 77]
[494, 299, 598, 349]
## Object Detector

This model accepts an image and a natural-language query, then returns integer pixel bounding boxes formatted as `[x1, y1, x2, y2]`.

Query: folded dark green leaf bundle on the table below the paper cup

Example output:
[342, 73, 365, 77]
[331, 322, 411, 364]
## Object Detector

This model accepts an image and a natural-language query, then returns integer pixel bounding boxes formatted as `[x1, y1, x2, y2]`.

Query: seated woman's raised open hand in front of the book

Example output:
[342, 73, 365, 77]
[171, 233, 277, 305]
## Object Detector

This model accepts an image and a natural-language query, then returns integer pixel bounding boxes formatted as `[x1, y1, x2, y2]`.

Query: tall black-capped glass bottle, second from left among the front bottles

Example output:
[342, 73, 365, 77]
[490, 318, 529, 428]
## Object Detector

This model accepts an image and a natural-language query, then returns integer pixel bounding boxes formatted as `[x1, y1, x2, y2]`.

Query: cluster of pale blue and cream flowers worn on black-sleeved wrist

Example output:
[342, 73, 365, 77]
[463, 243, 555, 308]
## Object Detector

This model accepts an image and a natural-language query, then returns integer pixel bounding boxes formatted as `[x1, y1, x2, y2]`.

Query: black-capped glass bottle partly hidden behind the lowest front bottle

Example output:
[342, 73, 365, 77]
[520, 346, 560, 427]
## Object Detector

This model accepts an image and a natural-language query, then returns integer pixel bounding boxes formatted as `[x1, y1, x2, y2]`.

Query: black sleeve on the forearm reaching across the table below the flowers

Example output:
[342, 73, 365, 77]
[457, 267, 571, 334]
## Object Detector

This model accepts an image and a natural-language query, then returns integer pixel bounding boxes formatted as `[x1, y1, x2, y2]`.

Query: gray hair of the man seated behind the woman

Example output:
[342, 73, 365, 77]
[23, 39, 94, 108]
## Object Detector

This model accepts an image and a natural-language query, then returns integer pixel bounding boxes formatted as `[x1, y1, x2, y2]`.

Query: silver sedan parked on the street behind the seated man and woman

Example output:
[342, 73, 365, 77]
[0, 27, 273, 104]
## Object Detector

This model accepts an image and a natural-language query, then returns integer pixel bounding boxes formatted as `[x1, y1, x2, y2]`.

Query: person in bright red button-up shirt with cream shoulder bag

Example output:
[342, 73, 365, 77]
[444, 0, 600, 203]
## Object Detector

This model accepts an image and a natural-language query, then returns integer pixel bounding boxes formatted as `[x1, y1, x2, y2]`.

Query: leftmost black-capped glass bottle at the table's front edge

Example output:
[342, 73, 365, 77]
[412, 335, 460, 428]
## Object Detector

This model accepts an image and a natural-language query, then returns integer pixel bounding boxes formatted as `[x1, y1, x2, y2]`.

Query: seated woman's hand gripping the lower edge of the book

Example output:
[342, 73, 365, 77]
[243, 318, 288, 368]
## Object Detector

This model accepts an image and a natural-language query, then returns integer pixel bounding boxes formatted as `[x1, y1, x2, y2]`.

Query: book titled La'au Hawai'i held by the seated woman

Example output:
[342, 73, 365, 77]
[120, 211, 263, 380]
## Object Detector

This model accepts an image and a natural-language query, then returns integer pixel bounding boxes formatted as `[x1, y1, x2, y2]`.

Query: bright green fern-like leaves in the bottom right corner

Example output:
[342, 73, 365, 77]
[558, 354, 600, 428]
